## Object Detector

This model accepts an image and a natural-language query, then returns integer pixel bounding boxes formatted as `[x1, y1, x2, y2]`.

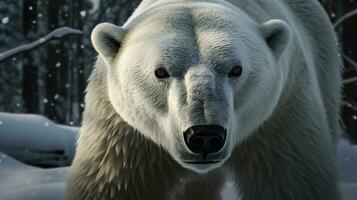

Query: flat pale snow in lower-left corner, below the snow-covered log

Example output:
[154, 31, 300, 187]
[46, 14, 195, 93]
[0, 153, 68, 200]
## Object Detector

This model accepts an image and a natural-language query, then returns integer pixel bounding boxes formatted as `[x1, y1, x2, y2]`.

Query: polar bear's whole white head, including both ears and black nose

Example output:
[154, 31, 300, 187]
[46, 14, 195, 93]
[92, 3, 290, 172]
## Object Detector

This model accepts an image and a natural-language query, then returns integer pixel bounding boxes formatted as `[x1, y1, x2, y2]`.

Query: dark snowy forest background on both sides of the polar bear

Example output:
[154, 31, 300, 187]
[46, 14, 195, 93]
[0, 0, 357, 141]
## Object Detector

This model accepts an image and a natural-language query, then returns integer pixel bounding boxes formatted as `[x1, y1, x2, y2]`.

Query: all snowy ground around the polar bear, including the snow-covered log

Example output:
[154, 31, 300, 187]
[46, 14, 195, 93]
[0, 113, 357, 200]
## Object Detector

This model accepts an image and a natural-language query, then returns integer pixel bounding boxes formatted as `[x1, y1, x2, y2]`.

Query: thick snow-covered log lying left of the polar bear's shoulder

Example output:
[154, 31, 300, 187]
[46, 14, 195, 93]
[0, 112, 78, 167]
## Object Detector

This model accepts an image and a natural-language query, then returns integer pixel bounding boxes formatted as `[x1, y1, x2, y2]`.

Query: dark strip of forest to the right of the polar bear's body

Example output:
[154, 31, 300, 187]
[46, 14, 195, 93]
[321, 0, 357, 143]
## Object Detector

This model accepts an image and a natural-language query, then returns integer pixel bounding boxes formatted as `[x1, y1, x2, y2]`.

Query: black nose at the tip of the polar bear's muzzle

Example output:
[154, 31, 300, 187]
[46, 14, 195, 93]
[183, 125, 227, 158]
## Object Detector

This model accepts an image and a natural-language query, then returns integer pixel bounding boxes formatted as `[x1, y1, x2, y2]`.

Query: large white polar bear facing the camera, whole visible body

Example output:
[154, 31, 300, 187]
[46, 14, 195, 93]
[67, 0, 341, 200]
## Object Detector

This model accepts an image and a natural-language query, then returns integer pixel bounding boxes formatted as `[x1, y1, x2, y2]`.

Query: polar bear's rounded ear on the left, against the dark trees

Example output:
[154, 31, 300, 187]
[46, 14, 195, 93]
[91, 23, 126, 65]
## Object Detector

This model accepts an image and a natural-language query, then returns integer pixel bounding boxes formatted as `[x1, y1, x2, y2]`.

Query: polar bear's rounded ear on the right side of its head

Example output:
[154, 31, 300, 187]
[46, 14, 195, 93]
[260, 19, 291, 59]
